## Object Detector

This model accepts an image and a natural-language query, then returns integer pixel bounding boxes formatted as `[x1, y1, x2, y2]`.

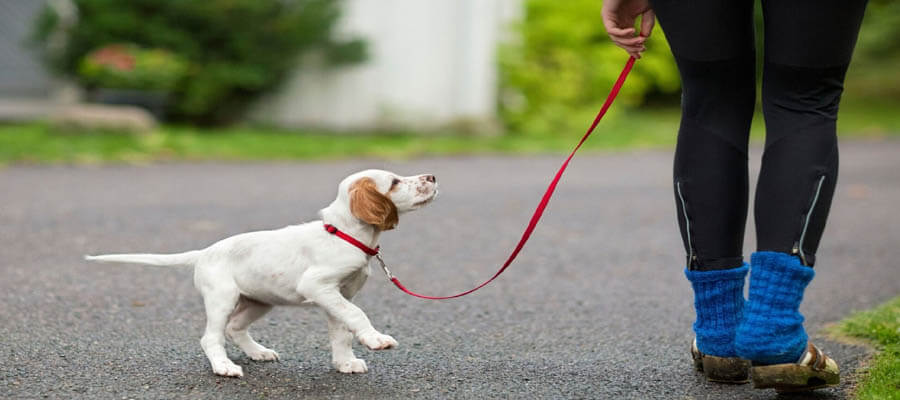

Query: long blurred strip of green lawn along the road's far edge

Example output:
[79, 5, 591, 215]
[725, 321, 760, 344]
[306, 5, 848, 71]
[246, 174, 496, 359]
[0, 101, 900, 165]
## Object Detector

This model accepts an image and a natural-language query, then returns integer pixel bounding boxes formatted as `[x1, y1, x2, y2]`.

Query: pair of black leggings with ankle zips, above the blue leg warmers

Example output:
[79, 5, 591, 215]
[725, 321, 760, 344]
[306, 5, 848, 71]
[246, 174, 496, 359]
[651, 0, 866, 270]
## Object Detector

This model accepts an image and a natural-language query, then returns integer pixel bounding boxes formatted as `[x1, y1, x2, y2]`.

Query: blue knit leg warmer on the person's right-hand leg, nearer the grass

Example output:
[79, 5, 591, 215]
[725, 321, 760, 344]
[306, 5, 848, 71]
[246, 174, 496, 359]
[734, 251, 815, 364]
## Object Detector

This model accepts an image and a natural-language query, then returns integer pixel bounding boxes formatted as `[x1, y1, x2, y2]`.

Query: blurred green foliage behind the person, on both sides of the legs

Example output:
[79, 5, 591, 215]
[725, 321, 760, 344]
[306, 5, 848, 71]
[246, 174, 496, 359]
[499, 0, 900, 134]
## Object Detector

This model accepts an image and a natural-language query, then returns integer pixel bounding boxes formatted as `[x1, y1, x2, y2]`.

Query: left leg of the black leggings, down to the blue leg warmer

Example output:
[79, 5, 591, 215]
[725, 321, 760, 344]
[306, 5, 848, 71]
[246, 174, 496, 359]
[653, 0, 756, 271]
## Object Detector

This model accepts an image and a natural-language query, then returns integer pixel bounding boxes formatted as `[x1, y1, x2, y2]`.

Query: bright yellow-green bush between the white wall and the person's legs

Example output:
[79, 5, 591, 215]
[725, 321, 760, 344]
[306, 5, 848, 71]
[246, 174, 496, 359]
[500, 0, 680, 134]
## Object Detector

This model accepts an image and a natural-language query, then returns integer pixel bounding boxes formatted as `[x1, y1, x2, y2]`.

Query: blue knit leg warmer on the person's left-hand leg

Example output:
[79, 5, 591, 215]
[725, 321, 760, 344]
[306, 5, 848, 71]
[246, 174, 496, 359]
[684, 264, 749, 357]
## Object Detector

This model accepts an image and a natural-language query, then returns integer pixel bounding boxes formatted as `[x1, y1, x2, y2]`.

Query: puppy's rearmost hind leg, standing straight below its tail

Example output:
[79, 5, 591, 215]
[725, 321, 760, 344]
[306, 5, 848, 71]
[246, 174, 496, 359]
[200, 287, 244, 377]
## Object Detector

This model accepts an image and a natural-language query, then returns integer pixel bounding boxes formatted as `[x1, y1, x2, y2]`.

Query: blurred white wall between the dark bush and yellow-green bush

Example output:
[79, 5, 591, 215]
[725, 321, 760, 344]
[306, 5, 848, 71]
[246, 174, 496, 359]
[252, 0, 521, 130]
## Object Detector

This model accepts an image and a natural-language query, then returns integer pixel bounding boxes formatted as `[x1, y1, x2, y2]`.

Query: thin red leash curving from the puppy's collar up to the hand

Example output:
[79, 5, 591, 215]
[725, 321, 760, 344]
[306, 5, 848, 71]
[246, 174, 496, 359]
[392, 57, 634, 300]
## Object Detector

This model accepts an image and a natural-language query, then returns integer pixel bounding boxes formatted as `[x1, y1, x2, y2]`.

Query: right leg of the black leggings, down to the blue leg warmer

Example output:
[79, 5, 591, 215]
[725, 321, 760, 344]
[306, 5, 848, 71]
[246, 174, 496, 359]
[754, 0, 866, 266]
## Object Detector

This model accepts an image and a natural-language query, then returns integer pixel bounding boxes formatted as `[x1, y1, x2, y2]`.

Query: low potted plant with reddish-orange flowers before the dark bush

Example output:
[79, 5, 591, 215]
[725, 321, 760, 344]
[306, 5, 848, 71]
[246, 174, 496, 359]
[78, 44, 187, 92]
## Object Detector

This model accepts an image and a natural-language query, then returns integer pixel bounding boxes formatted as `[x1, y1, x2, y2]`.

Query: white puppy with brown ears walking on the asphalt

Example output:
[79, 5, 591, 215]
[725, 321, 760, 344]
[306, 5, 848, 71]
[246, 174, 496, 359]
[85, 170, 438, 377]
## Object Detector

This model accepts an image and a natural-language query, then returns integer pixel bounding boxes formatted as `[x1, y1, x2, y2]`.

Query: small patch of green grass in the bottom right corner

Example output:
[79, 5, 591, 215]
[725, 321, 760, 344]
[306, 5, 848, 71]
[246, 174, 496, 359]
[831, 297, 900, 400]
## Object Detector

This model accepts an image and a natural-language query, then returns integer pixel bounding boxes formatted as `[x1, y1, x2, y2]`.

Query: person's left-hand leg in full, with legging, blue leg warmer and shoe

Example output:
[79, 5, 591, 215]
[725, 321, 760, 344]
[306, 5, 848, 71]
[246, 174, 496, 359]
[653, 0, 756, 382]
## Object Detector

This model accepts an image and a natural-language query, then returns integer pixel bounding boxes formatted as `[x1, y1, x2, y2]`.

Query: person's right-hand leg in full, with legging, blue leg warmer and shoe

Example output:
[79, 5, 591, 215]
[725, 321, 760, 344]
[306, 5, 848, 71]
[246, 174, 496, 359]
[735, 0, 865, 390]
